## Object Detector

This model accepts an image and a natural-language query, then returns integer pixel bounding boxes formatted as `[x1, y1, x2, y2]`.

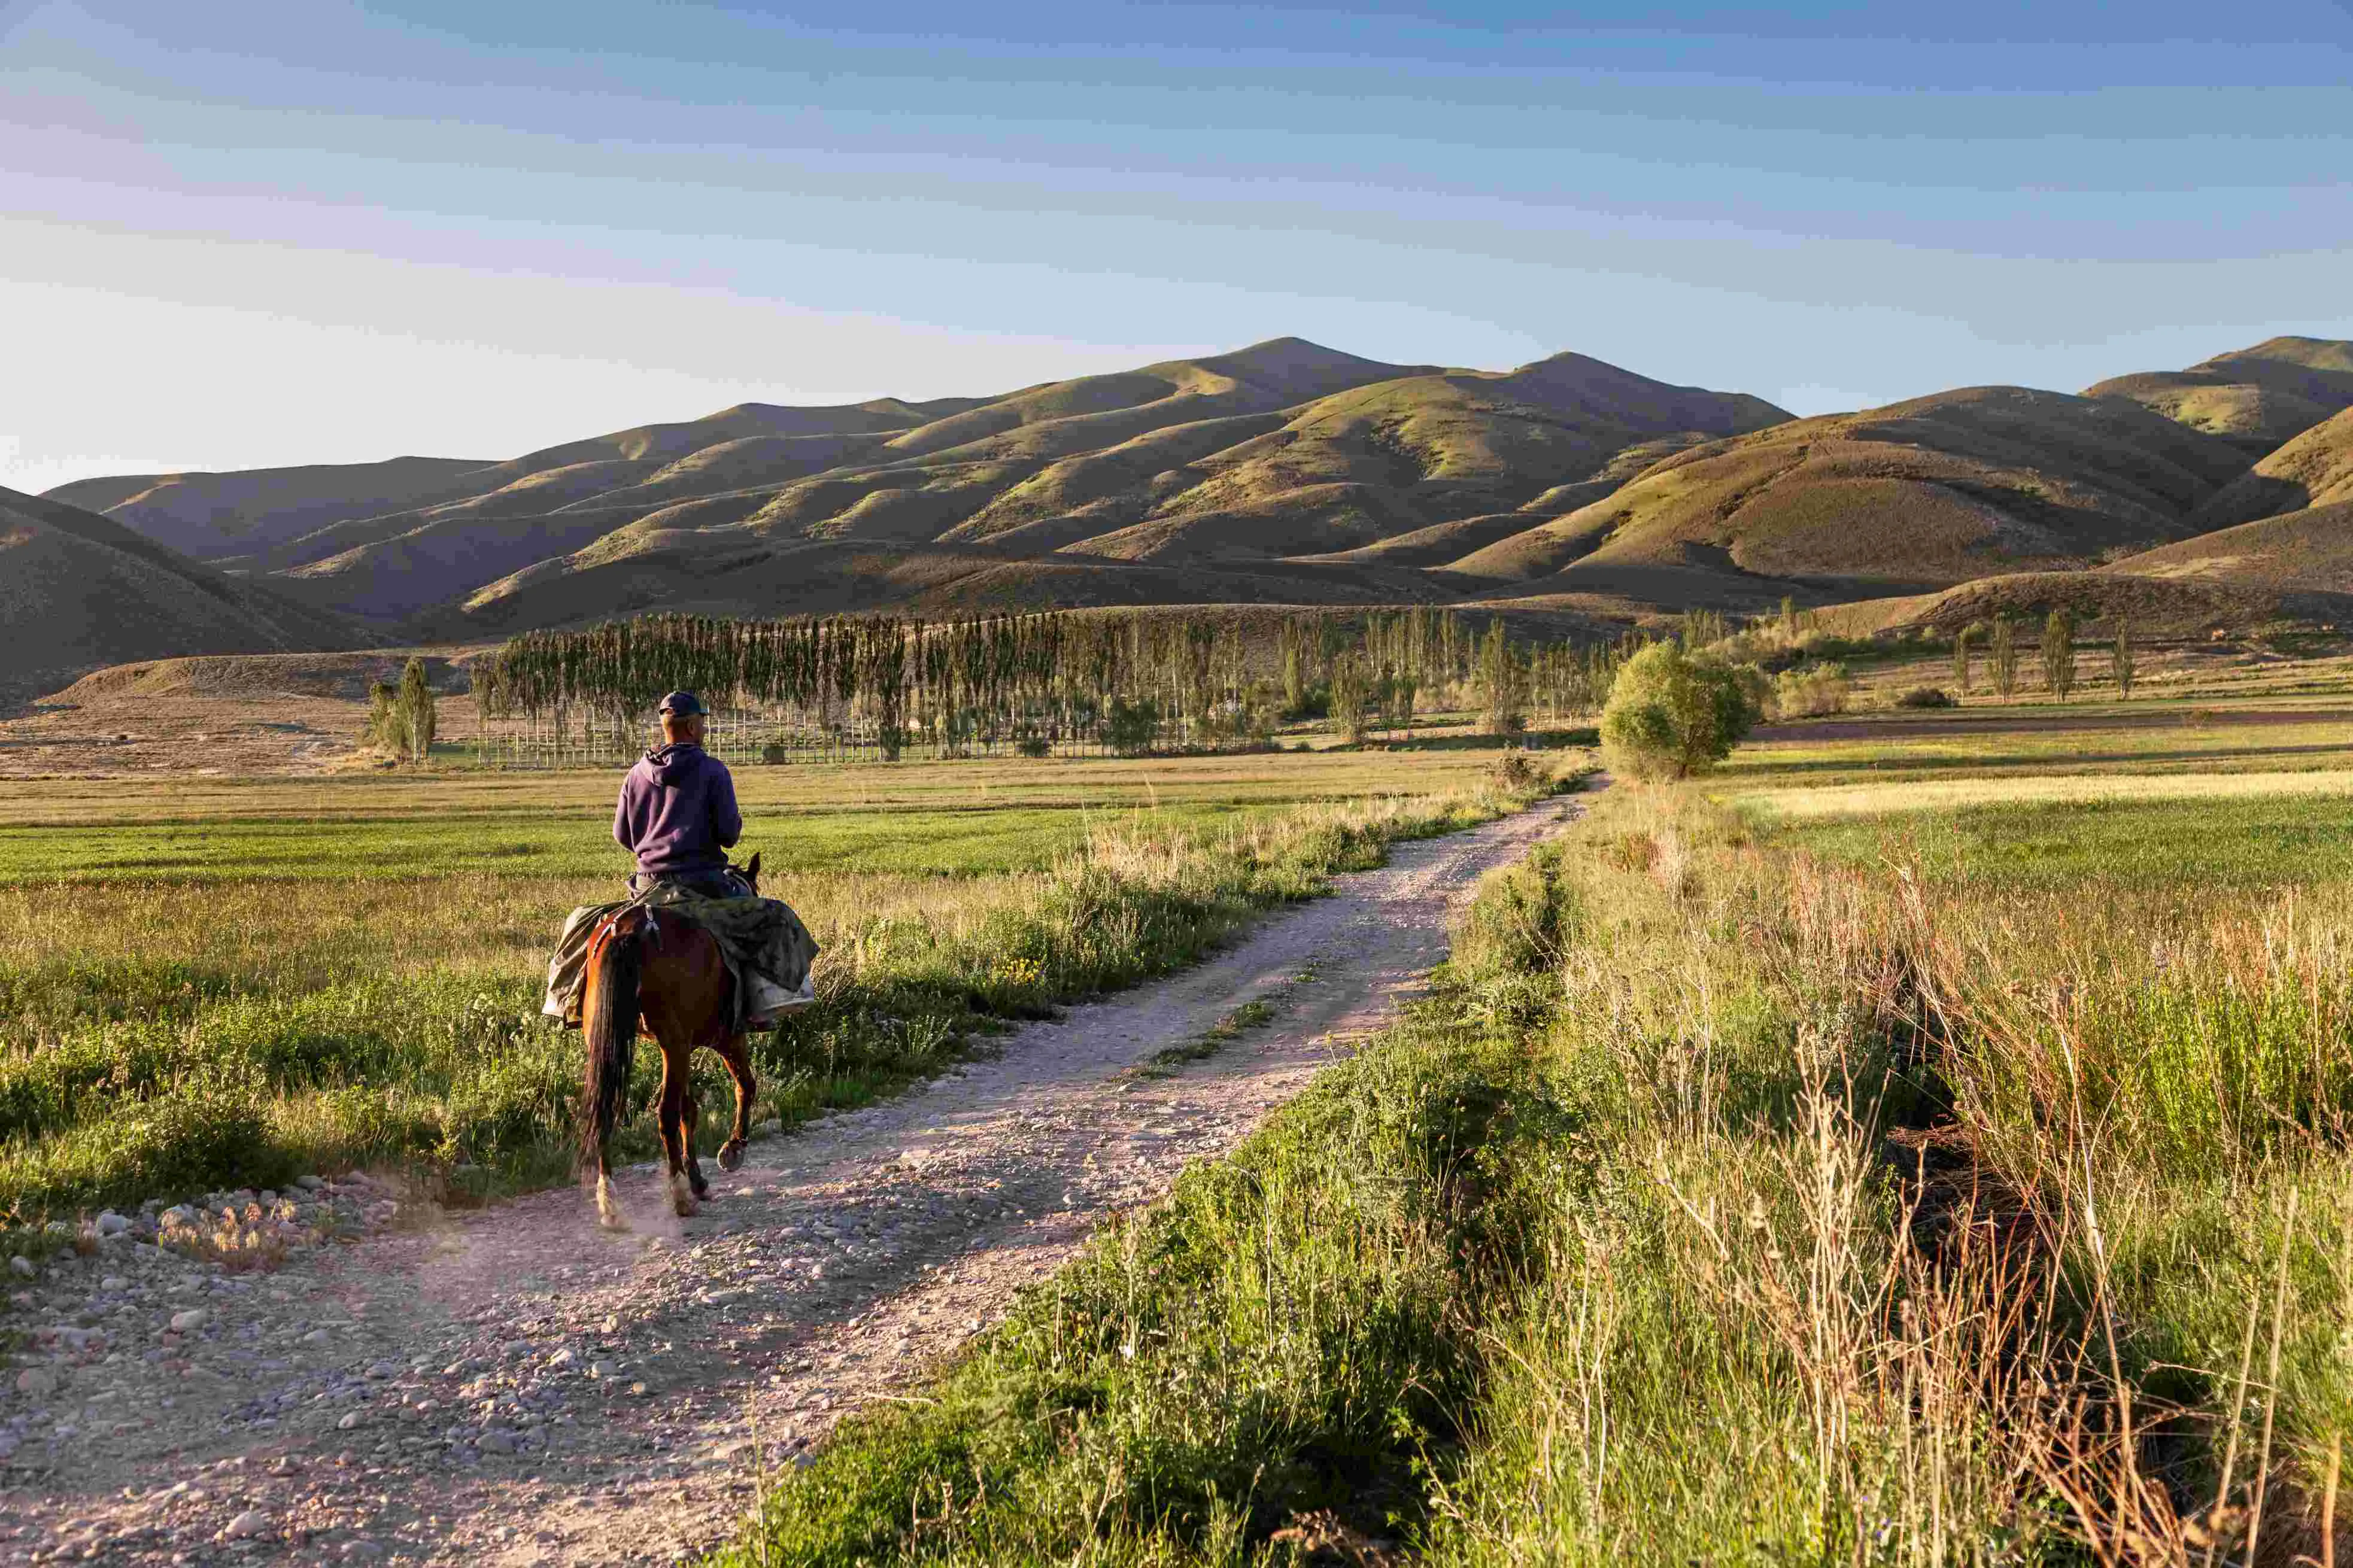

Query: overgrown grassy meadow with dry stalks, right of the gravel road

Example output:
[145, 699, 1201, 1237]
[722, 692, 2353, 1568]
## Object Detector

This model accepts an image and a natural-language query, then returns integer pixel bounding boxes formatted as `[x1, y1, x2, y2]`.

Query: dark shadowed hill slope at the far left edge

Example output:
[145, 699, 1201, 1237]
[0, 490, 356, 695]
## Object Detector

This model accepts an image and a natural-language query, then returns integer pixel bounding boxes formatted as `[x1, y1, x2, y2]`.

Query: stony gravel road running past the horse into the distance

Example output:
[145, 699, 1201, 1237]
[0, 803, 1567, 1566]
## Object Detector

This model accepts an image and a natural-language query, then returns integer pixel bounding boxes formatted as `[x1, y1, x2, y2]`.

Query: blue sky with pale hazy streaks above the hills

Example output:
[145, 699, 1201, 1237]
[0, 0, 2353, 490]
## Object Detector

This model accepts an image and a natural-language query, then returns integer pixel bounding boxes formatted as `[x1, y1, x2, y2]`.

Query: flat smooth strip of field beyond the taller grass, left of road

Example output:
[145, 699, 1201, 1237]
[0, 753, 1525, 885]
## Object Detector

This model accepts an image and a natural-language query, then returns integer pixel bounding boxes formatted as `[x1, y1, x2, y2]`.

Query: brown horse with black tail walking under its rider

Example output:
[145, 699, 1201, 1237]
[581, 855, 760, 1229]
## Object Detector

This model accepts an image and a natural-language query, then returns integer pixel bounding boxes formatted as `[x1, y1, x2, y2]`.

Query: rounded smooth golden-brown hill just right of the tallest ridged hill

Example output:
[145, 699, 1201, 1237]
[1447, 386, 2245, 607]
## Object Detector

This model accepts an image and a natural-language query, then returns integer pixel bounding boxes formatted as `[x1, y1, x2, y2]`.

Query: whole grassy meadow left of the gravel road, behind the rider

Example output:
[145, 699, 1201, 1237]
[0, 751, 1543, 1224]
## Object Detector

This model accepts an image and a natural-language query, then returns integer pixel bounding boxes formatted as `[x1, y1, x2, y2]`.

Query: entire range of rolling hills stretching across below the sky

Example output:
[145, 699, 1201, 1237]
[18, 337, 2353, 692]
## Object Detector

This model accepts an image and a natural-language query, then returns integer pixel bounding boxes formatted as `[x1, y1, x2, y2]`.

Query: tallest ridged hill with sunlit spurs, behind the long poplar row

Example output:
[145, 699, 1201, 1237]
[45, 339, 1786, 636]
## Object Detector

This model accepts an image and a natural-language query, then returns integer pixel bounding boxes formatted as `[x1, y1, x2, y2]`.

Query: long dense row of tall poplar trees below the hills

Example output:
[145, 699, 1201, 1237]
[475, 607, 1631, 761]
